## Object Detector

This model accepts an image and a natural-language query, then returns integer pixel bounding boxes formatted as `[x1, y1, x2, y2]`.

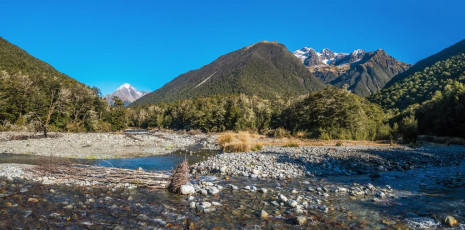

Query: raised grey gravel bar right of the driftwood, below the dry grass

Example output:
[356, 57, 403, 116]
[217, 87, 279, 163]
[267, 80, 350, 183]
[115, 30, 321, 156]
[192, 146, 465, 179]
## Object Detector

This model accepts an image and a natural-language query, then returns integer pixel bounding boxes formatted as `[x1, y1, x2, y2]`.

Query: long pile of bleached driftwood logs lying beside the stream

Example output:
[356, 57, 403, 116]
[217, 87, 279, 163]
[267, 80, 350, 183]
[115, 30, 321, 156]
[34, 164, 170, 189]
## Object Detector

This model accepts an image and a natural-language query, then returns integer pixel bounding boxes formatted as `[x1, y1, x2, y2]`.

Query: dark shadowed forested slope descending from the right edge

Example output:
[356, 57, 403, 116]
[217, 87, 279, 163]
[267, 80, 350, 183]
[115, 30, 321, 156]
[370, 38, 465, 110]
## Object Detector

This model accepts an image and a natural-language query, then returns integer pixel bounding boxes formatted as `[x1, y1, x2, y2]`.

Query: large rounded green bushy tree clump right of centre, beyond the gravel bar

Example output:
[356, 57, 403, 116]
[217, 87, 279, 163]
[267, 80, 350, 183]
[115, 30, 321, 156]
[281, 87, 389, 140]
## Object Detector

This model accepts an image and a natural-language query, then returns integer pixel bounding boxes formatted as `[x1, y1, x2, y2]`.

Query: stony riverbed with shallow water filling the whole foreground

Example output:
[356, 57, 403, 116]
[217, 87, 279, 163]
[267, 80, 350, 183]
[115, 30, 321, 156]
[0, 136, 465, 229]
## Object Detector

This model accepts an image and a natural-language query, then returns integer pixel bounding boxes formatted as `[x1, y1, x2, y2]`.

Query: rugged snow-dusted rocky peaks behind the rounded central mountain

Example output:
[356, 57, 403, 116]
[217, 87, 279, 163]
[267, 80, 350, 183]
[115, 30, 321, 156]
[294, 47, 410, 96]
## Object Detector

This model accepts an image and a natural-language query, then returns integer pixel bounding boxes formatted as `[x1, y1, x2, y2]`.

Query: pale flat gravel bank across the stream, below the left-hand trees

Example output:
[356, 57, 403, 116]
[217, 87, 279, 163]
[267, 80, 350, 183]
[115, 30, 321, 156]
[0, 131, 216, 159]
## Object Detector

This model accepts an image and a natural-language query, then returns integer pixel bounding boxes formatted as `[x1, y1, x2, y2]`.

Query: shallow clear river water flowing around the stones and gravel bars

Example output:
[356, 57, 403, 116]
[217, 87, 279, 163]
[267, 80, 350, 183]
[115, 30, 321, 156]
[0, 151, 465, 229]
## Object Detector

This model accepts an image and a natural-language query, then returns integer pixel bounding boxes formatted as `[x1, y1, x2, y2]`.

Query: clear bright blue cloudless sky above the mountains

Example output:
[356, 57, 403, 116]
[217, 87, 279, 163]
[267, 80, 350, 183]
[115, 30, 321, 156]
[0, 0, 465, 94]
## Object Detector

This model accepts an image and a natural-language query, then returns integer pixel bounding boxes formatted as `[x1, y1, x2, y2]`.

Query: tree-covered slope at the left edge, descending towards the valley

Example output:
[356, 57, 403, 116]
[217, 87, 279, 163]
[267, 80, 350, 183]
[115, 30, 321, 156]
[0, 37, 104, 130]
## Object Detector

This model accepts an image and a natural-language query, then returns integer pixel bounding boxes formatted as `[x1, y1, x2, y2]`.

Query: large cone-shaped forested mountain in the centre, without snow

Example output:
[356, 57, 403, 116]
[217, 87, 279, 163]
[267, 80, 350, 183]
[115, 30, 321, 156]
[132, 42, 325, 106]
